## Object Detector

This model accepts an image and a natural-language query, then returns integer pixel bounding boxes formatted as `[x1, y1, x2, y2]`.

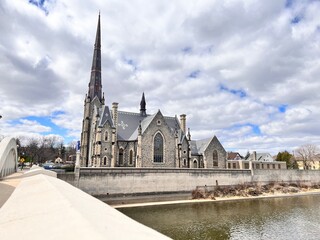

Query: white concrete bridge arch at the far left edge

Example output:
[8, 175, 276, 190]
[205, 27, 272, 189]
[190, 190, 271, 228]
[0, 137, 18, 178]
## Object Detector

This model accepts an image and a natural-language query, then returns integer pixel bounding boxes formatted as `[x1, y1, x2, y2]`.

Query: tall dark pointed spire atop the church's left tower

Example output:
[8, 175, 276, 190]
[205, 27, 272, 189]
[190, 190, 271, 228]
[88, 12, 102, 102]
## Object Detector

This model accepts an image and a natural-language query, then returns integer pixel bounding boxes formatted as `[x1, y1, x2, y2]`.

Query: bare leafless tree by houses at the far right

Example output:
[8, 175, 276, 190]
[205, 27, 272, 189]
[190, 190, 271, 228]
[295, 144, 320, 169]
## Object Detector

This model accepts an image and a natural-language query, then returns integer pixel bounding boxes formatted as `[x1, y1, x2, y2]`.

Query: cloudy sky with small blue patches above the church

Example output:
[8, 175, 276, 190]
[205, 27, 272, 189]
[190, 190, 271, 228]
[0, 0, 320, 154]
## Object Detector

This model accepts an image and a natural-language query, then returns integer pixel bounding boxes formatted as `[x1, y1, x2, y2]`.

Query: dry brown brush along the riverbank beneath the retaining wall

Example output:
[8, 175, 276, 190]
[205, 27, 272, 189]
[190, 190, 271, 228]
[192, 183, 320, 200]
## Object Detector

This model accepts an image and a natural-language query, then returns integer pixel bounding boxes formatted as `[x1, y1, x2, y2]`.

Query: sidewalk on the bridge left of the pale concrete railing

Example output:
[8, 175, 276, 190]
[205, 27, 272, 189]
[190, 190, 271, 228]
[0, 169, 29, 208]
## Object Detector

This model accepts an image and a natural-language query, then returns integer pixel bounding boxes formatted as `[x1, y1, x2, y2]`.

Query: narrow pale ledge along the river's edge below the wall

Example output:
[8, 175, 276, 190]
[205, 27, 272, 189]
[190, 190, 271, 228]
[111, 188, 320, 209]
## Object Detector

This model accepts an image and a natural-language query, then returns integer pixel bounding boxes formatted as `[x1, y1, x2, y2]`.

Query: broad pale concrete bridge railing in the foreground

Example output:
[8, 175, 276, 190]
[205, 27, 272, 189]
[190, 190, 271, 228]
[0, 174, 169, 240]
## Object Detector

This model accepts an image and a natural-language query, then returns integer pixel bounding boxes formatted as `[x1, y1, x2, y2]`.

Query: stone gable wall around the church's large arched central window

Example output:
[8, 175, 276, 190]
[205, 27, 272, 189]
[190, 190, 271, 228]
[141, 113, 175, 168]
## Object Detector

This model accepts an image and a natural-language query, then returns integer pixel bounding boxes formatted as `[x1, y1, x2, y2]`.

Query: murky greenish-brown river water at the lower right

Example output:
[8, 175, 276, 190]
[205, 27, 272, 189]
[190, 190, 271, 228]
[119, 195, 320, 240]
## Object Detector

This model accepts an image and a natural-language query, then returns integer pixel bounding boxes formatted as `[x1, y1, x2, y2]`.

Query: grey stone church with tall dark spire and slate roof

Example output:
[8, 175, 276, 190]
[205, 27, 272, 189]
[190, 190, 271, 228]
[80, 15, 227, 168]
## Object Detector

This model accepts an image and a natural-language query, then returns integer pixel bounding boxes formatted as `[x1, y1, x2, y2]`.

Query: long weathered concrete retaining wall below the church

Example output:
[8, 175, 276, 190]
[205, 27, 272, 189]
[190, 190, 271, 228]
[58, 168, 320, 196]
